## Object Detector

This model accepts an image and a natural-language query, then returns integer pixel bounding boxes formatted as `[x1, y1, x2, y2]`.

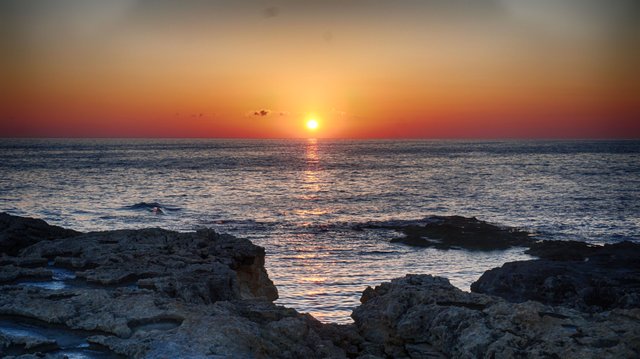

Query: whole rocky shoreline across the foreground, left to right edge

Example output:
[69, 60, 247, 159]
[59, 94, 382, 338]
[0, 214, 640, 359]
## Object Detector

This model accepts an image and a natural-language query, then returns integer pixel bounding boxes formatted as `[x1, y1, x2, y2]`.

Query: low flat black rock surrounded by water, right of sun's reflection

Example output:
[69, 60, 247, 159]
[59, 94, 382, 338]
[386, 216, 533, 250]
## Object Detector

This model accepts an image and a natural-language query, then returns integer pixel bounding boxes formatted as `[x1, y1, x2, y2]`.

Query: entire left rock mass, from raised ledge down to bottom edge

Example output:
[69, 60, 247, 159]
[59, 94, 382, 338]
[0, 217, 358, 358]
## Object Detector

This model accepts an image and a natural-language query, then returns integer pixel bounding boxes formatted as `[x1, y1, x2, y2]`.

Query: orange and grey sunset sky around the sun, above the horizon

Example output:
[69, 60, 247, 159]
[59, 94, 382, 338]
[0, 0, 640, 138]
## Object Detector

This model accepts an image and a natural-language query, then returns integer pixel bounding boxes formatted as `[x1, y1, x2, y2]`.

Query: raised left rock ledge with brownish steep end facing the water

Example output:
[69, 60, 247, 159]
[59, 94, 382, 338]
[16, 228, 277, 303]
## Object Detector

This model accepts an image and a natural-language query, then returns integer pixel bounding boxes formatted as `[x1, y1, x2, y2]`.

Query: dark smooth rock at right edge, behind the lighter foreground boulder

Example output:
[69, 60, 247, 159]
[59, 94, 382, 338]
[471, 241, 640, 312]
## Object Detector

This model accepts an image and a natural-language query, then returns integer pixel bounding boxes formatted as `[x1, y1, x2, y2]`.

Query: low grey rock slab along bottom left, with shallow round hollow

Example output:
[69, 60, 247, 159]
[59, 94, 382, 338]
[0, 286, 346, 358]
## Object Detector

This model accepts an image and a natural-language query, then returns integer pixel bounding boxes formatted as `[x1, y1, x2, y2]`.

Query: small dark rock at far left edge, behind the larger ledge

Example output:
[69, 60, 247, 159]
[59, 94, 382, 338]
[0, 213, 79, 255]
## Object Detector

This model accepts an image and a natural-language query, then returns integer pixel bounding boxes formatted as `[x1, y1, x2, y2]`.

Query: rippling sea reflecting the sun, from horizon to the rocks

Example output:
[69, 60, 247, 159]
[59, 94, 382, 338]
[0, 139, 640, 323]
